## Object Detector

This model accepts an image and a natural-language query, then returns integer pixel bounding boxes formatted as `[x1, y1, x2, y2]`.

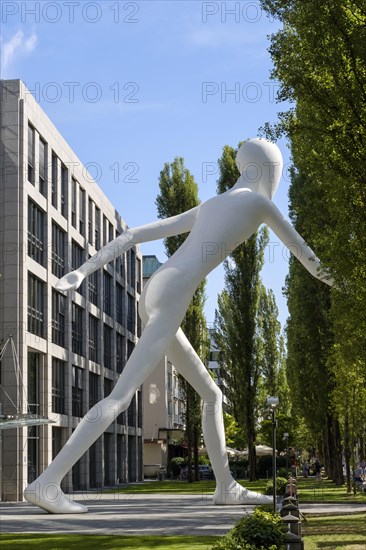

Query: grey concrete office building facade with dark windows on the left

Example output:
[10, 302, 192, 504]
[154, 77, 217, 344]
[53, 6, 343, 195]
[0, 80, 143, 500]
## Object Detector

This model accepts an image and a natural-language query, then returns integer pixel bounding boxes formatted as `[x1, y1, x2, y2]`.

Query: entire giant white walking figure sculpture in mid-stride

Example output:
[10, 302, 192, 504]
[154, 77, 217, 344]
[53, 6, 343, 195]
[24, 138, 331, 514]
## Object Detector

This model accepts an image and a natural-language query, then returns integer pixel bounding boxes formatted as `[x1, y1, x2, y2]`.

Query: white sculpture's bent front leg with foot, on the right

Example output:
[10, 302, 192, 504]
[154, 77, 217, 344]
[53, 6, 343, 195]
[168, 329, 272, 504]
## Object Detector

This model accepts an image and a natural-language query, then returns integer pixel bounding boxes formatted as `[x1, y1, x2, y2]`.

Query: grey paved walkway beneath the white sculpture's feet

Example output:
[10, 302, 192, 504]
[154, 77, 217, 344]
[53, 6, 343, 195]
[0, 493, 366, 535]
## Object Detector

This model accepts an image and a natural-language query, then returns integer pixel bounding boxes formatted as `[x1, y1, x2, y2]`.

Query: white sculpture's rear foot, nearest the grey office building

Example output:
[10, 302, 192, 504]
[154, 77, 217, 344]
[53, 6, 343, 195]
[24, 478, 88, 514]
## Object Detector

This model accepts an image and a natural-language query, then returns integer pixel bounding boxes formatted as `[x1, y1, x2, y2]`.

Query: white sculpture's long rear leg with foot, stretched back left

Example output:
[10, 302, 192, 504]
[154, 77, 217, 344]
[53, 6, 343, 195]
[24, 318, 177, 514]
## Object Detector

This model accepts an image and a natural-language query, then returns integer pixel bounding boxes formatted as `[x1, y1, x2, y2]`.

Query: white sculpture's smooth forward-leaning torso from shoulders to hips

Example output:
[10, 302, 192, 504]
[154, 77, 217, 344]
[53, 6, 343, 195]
[141, 189, 268, 320]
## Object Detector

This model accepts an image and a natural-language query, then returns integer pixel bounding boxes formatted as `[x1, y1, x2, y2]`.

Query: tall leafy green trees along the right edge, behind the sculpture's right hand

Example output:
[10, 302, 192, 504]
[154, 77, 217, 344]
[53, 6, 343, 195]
[261, 0, 366, 481]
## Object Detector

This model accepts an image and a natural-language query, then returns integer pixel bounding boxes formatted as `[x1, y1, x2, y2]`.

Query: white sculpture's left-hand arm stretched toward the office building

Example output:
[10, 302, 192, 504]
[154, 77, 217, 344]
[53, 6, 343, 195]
[56, 206, 199, 290]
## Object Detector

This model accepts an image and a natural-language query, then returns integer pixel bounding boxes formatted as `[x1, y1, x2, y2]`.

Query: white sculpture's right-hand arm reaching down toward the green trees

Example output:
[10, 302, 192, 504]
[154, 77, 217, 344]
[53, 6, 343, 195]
[264, 201, 334, 286]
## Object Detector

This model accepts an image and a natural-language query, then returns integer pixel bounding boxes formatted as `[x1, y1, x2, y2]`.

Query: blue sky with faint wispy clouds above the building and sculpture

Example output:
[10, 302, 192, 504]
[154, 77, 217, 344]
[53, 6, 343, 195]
[1, 0, 289, 325]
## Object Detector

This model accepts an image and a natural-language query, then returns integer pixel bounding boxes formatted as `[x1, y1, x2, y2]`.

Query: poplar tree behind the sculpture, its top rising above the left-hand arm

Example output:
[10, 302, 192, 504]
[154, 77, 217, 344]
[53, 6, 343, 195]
[156, 157, 208, 482]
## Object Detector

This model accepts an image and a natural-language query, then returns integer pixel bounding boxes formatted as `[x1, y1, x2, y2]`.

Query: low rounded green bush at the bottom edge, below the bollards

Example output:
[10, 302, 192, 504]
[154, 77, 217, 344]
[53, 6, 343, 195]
[213, 508, 284, 550]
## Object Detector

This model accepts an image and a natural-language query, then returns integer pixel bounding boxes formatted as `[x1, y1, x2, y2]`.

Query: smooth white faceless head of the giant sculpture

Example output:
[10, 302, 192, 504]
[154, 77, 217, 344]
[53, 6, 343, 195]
[236, 138, 283, 199]
